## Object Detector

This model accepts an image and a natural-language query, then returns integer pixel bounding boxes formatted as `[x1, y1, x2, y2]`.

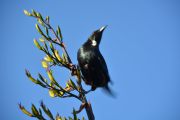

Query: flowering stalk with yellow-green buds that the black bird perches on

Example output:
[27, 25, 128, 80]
[21, 10, 95, 120]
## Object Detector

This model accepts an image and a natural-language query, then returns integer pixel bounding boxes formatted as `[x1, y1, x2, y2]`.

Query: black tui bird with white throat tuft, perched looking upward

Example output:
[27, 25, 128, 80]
[77, 26, 112, 95]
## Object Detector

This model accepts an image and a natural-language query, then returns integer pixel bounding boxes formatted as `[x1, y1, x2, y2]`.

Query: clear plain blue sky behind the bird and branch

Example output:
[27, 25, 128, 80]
[0, 0, 180, 120]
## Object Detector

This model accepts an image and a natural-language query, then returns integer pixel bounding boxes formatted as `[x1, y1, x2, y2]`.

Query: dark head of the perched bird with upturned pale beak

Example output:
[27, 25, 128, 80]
[87, 25, 107, 46]
